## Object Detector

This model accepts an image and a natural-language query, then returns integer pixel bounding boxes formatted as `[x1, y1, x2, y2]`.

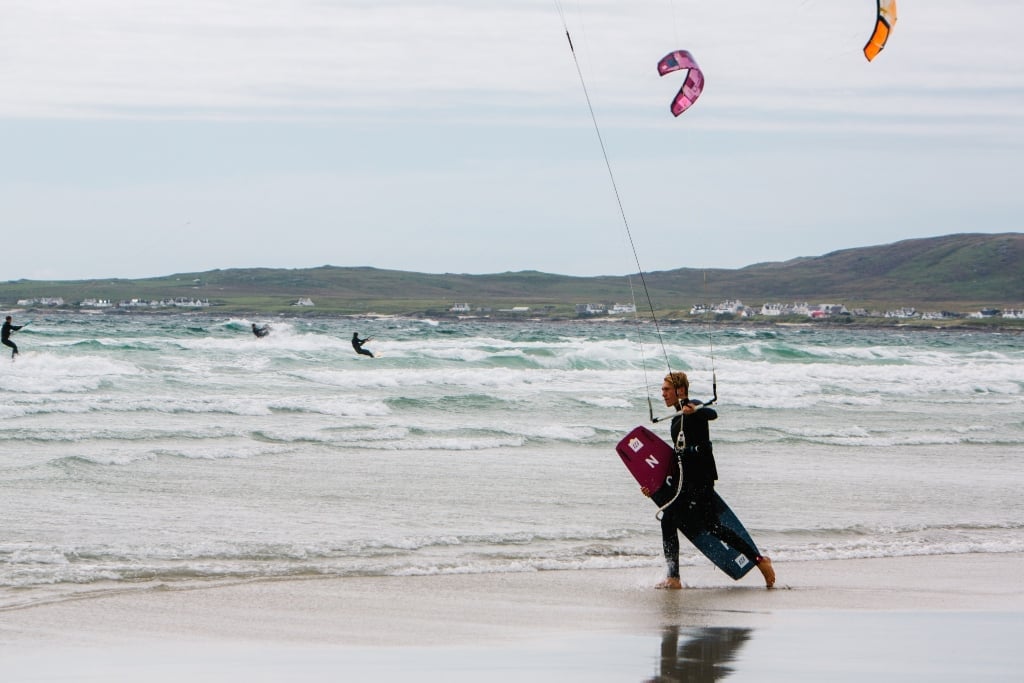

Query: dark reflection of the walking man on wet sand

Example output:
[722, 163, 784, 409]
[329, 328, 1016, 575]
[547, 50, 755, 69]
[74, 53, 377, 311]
[645, 626, 754, 683]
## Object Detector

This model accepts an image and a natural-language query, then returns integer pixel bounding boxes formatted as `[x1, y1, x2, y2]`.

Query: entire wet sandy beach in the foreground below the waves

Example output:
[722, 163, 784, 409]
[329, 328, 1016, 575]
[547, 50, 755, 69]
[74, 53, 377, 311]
[0, 554, 1024, 681]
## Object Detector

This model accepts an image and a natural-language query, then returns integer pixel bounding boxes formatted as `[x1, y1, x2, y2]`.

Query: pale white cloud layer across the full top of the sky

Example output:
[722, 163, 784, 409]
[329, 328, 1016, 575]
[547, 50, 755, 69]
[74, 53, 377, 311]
[0, 0, 1024, 135]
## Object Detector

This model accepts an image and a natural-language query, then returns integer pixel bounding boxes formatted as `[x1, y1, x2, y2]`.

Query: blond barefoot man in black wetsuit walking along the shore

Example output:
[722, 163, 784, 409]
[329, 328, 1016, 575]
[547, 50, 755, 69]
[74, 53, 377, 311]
[640, 373, 775, 589]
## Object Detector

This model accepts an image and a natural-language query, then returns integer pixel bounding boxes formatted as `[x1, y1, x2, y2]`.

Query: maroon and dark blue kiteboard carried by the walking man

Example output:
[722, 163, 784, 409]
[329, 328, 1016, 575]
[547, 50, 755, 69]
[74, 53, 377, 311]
[615, 426, 757, 581]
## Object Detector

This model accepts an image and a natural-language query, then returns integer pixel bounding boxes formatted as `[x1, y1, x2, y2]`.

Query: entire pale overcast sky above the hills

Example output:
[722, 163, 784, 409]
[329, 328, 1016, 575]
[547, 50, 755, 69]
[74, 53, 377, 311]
[0, 0, 1024, 280]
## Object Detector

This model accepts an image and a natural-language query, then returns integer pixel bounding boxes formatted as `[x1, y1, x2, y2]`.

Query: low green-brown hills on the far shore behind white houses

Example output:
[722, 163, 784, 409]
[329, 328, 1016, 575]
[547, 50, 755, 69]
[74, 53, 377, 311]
[0, 232, 1024, 314]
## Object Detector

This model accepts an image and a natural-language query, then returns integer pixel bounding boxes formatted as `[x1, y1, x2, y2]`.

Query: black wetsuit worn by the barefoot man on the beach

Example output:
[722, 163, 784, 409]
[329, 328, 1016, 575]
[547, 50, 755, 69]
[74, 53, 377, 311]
[651, 401, 760, 579]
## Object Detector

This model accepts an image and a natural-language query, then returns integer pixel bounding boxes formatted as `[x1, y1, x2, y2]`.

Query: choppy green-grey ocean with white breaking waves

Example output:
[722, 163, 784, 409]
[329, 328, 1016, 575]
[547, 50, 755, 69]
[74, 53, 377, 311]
[0, 314, 1024, 608]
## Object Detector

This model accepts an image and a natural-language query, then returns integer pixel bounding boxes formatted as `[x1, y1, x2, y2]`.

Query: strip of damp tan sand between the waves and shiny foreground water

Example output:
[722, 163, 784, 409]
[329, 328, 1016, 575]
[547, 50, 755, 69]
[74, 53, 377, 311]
[0, 553, 1024, 649]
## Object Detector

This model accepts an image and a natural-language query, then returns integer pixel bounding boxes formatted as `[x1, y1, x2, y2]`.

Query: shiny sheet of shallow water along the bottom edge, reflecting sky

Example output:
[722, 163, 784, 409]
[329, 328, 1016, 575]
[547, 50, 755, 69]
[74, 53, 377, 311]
[0, 611, 1021, 683]
